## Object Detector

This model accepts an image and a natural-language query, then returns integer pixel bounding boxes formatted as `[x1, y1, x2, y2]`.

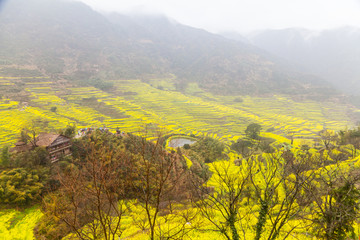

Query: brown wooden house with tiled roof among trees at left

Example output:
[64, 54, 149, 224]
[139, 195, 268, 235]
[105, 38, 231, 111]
[11, 133, 71, 162]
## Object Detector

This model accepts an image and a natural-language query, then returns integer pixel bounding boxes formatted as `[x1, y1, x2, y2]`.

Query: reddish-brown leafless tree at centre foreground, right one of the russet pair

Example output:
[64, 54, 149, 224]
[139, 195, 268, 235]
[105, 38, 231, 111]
[128, 132, 194, 239]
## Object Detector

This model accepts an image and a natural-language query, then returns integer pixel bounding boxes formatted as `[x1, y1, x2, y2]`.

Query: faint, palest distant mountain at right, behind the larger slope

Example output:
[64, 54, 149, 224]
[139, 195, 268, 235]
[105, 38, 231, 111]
[249, 27, 360, 94]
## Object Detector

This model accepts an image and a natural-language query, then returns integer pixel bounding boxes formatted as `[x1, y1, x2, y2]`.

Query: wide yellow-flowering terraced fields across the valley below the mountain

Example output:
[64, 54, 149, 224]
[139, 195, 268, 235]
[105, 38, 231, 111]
[0, 78, 356, 145]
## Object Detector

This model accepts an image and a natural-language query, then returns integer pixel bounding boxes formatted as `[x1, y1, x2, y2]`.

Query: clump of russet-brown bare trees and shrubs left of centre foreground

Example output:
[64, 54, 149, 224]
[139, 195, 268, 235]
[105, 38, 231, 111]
[36, 131, 205, 239]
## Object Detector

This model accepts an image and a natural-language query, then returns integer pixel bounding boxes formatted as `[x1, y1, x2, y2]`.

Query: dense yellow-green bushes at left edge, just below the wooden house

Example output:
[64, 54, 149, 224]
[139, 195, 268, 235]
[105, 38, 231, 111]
[0, 135, 51, 207]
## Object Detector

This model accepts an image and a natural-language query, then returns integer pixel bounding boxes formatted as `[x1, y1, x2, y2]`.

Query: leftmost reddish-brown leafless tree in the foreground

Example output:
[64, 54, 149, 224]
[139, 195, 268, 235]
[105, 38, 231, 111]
[44, 142, 131, 239]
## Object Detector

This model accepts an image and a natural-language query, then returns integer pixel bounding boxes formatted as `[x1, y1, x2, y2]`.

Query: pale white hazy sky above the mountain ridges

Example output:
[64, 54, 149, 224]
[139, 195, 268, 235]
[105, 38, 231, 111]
[79, 0, 360, 33]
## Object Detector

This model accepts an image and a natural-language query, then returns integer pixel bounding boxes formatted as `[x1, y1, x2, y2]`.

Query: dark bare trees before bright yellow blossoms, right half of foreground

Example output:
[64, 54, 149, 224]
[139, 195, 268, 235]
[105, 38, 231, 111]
[195, 149, 360, 239]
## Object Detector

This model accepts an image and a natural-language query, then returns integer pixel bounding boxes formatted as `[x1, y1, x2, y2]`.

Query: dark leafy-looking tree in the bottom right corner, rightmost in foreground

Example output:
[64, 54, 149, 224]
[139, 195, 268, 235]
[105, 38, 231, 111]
[300, 156, 360, 240]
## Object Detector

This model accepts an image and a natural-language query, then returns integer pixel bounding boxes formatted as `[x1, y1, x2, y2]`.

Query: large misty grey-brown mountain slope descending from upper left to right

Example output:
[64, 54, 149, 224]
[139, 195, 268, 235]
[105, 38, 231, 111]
[0, 0, 335, 97]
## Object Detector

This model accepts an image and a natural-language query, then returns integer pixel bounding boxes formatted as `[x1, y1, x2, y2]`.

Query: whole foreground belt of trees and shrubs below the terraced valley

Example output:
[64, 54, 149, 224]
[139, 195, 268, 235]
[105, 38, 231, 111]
[0, 124, 360, 240]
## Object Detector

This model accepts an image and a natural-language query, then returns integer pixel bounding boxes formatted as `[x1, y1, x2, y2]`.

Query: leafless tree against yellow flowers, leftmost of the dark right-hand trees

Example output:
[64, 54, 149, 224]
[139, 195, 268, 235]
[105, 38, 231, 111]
[193, 158, 252, 240]
